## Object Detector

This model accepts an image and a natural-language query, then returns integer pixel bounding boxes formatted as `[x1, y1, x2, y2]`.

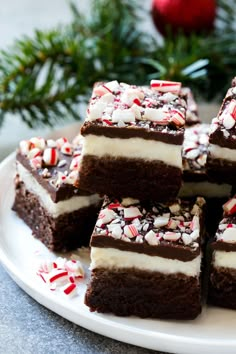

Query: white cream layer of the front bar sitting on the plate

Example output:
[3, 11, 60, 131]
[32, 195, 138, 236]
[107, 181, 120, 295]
[90, 247, 201, 276]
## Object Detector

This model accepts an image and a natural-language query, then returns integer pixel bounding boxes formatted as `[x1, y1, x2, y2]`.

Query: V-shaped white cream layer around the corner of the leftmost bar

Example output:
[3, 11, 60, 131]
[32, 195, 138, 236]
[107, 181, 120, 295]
[17, 163, 99, 218]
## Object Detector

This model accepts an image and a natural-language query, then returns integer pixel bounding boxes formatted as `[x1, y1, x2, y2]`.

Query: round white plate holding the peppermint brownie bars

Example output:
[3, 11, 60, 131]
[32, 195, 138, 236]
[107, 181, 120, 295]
[0, 154, 236, 354]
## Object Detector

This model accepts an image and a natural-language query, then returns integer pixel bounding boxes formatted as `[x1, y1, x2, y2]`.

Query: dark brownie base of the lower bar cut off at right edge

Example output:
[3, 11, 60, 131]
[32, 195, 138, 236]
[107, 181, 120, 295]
[208, 267, 236, 309]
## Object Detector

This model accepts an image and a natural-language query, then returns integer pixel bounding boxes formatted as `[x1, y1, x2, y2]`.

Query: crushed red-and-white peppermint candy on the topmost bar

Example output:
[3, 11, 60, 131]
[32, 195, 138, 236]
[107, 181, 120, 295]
[87, 80, 186, 130]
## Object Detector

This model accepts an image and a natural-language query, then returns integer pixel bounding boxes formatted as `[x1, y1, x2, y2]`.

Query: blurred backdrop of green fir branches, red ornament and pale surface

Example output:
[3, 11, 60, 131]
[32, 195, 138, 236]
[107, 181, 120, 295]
[0, 0, 236, 159]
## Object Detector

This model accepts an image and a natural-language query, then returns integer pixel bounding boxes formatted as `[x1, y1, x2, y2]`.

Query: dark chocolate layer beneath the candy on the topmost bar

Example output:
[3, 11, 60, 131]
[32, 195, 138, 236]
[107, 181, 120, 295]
[81, 121, 184, 145]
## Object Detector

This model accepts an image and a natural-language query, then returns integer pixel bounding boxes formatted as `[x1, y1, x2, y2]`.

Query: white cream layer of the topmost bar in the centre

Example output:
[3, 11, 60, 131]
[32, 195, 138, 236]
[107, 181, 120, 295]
[83, 134, 182, 169]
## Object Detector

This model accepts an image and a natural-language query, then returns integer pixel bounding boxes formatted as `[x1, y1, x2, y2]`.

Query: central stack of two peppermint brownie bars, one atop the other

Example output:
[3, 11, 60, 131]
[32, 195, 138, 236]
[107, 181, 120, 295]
[77, 80, 205, 319]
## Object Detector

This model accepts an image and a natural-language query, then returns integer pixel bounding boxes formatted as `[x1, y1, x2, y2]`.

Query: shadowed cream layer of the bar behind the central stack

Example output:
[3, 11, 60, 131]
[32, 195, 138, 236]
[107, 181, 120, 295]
[179, 181, 232, 198]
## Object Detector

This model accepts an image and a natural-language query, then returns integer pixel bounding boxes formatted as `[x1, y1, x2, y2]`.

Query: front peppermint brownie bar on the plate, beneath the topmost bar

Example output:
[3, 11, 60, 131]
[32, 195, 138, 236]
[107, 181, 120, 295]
[85, 198, 205, 319]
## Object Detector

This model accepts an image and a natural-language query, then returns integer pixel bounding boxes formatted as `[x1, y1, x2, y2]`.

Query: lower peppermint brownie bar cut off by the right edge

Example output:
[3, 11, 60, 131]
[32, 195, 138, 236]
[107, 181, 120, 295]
[208, 197, 236, 309]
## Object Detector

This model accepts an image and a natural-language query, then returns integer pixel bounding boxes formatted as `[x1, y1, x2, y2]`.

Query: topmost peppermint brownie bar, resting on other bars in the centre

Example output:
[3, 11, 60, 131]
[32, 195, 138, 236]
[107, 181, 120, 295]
[80, 80, 186, 201]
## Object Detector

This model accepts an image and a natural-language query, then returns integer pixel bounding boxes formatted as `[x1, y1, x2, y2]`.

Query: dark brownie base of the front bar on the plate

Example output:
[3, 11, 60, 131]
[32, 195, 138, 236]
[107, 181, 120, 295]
[85, 269, 201, 320]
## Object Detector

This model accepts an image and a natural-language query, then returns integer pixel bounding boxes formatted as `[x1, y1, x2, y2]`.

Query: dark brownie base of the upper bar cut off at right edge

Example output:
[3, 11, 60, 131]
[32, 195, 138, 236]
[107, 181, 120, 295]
[207, 158, 236, 185]
